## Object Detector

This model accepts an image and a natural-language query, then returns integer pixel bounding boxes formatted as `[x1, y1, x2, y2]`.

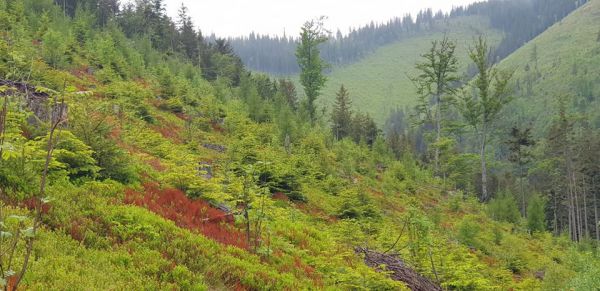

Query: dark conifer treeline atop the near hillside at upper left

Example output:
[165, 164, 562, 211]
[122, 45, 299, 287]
[51, 0, 243, 85]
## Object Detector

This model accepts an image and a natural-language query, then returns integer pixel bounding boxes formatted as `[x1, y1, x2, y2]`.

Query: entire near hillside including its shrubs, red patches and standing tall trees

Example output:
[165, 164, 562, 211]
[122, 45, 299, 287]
[0, 0, 600, 290]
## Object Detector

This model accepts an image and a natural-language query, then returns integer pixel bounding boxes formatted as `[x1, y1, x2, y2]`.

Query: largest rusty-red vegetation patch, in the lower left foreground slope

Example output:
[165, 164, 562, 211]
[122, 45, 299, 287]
[125, 183, 248, 249]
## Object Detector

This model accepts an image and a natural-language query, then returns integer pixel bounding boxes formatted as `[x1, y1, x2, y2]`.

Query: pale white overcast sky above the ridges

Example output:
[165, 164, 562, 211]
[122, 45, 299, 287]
[165, 0, 486, 37]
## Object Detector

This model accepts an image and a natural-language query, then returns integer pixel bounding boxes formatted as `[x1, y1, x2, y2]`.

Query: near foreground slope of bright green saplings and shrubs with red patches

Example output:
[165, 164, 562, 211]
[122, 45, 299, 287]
[0, 0, 600, 290]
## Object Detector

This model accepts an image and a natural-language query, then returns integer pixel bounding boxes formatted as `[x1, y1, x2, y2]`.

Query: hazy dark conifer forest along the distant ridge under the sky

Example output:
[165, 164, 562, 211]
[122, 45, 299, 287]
[229, 0, 587, 75]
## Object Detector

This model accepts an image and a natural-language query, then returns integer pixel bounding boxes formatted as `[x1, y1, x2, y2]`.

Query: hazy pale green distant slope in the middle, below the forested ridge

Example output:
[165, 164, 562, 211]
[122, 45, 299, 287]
[321, 16, 501, 124]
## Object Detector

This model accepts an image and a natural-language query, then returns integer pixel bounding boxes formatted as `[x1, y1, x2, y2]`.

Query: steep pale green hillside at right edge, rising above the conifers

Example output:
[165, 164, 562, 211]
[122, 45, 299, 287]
[500, 0, 600, 133]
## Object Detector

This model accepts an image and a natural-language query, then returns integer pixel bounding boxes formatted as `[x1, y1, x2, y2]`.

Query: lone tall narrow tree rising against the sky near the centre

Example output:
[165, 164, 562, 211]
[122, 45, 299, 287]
[296, 17, 327, 123]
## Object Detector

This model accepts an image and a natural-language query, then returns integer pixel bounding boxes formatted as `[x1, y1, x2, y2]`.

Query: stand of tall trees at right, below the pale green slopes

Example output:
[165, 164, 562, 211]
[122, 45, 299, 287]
[385, 34, 600, 246]
